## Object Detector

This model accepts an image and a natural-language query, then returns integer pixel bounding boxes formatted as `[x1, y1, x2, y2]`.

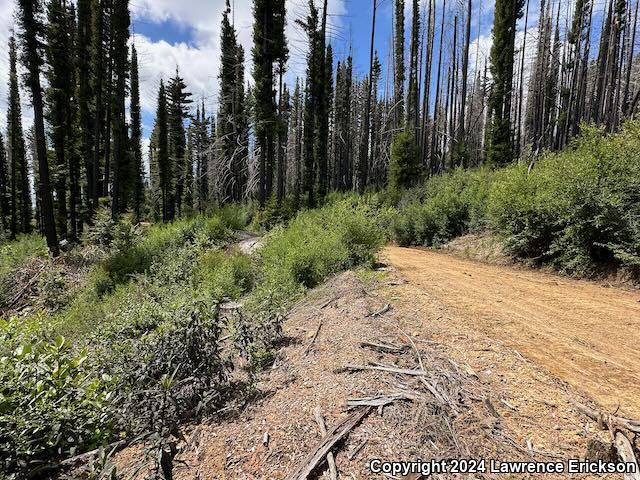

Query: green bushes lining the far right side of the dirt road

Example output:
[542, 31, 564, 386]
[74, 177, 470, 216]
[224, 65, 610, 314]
[393, 122, 640, 277]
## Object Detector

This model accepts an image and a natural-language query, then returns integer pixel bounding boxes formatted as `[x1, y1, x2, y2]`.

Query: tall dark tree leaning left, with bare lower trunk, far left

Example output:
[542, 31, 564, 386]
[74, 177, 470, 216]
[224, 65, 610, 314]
[18, 0, 60, 256]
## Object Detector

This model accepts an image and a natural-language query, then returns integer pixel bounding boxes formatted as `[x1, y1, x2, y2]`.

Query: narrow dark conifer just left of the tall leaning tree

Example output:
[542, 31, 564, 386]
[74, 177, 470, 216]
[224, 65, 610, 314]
[7, 36, 32, 238]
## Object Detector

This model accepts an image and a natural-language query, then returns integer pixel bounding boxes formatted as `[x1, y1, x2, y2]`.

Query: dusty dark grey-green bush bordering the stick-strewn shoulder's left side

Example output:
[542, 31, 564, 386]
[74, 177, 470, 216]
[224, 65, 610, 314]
[96, 302, 231, 434]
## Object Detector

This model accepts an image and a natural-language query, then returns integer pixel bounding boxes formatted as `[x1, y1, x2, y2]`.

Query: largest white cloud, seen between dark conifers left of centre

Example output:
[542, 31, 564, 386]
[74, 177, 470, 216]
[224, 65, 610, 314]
[132, 0, 346, 119]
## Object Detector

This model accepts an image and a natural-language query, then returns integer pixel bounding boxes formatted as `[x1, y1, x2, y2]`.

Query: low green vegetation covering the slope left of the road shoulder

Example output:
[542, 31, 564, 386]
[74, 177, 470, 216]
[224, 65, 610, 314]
[0, 197, 390, 478]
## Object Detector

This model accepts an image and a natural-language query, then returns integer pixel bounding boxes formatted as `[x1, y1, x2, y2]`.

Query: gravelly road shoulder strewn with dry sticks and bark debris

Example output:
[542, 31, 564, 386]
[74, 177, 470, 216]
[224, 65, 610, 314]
[111, 272, 632, 480]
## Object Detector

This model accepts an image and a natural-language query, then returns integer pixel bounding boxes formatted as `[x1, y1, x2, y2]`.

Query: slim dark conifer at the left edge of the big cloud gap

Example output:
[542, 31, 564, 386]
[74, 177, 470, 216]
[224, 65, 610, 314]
[130, 45, 144, 219]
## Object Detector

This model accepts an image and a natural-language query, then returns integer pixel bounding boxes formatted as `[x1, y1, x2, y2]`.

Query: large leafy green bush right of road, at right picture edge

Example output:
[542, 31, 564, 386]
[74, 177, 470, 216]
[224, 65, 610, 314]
[488, 122, 640, 276]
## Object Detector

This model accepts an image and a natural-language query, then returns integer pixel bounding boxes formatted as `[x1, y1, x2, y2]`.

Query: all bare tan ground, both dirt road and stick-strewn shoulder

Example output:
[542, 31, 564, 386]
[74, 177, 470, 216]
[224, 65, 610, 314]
[112, 247, 640, 480]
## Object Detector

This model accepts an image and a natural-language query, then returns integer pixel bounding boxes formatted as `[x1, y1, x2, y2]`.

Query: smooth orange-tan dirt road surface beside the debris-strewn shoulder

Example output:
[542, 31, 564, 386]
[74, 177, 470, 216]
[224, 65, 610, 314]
[384, 247, 640, 418]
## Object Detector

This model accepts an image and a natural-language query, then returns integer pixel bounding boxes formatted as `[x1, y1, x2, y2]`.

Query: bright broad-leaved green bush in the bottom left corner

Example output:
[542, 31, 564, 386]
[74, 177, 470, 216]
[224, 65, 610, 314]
[0, 322, 113, 472]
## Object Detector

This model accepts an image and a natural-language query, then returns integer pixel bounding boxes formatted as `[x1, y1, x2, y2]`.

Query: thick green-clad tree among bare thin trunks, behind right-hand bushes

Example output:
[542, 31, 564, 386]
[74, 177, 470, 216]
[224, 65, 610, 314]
[487, 0, 524, 165]
